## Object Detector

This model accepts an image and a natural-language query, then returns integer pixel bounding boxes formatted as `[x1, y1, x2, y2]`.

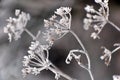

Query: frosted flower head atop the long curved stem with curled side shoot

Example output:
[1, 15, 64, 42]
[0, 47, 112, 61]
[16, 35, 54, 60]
[44, 7, 71, 45]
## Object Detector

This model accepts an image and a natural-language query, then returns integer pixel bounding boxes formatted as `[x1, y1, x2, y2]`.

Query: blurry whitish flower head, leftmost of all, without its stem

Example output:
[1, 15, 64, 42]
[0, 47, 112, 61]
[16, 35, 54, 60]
[4, 10, 30, 42]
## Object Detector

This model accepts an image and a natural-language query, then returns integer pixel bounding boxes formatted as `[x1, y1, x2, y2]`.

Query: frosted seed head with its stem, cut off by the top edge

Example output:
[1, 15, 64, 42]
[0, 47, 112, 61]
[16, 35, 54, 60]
[83, 0, 120, 39]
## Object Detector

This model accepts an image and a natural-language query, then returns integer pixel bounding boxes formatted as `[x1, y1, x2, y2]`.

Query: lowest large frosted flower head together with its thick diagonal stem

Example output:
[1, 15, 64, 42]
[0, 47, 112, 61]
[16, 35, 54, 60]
[22, 41, 73, 80]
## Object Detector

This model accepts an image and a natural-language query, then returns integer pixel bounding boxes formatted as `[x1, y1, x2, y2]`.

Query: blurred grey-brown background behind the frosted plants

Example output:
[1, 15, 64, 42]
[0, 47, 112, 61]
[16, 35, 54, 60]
[0, 0, 120, 80]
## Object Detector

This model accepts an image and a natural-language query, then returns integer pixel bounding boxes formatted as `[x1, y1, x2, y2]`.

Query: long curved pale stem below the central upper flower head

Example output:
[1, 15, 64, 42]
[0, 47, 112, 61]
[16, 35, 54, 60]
[70, 30, 94, 80]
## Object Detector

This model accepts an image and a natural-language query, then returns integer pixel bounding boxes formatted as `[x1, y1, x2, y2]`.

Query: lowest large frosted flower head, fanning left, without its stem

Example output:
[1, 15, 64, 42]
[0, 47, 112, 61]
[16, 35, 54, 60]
[22, 41, 51, 76]
